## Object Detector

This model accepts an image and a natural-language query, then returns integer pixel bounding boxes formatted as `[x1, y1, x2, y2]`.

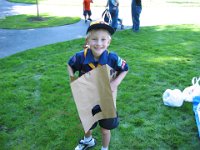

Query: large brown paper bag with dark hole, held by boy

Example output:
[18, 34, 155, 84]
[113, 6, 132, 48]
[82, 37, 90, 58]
[71, 65, 117, 132]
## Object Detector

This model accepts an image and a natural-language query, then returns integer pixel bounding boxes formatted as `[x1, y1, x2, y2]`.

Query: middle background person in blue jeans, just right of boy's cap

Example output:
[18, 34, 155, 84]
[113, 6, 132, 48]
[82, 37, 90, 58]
[106, 0, 119, 31]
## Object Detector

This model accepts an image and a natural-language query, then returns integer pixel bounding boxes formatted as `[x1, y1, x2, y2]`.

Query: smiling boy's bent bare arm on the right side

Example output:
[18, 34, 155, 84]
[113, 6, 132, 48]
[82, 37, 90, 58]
[110, 71, 128, 91]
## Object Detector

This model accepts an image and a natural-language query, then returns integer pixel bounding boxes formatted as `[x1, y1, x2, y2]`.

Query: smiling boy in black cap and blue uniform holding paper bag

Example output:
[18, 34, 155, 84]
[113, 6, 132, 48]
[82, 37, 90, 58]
[68, 21, 128, 150]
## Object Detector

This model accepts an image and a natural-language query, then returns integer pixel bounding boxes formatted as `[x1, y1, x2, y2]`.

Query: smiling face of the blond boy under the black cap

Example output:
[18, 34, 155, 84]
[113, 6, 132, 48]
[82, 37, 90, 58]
[86, 30, 111, 59]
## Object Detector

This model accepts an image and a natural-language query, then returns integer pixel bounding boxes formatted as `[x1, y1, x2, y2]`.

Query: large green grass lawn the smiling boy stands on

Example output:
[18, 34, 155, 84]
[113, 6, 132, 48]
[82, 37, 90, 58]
[0, 25, 200, 150]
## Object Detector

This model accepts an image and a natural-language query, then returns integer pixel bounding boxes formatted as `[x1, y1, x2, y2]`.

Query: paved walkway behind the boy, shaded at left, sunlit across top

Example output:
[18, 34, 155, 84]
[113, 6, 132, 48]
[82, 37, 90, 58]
[0, 0, 200, 58]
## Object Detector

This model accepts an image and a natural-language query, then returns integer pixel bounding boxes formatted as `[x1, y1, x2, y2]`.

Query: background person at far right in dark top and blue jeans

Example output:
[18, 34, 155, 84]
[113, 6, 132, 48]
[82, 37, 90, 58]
[131, 0, 142, 32]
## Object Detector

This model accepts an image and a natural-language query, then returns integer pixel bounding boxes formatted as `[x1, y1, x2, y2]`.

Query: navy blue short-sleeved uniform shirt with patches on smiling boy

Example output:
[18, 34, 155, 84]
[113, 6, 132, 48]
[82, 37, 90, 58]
[68, 49, 128, 76]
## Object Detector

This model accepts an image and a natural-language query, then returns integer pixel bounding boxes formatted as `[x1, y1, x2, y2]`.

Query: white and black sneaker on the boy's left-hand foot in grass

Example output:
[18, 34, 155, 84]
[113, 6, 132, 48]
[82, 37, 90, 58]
[75, 138, 96, 150]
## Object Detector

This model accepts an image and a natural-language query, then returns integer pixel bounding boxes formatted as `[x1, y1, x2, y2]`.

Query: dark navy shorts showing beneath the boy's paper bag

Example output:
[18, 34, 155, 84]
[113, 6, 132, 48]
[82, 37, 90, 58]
[90, 115, 119, 130]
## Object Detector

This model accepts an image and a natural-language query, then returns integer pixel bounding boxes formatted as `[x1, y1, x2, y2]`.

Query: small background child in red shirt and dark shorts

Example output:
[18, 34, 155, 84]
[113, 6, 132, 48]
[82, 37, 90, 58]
[83, 0, 93, 23]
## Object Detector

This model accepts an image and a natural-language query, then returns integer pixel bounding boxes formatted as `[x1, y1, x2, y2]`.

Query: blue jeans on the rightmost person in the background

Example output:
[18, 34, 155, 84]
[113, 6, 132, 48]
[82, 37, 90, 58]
[131, 2, 142, 31]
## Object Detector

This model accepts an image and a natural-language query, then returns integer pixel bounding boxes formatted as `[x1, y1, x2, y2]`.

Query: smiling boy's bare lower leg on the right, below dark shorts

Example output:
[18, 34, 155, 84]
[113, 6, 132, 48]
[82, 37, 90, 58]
[101, 128, 111, 149]
